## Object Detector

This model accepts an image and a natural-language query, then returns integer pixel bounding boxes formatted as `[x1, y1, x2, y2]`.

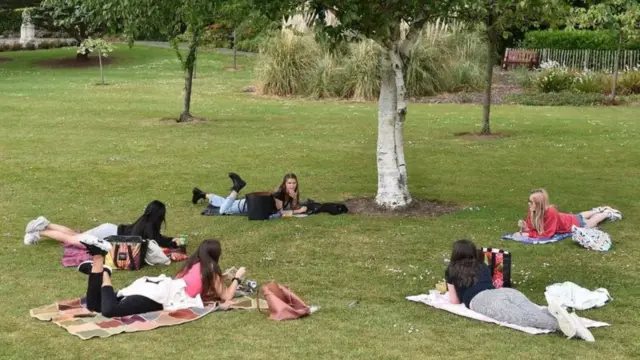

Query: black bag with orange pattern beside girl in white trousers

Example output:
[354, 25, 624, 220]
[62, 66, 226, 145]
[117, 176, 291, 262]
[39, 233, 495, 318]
[104, 235, 148, 270]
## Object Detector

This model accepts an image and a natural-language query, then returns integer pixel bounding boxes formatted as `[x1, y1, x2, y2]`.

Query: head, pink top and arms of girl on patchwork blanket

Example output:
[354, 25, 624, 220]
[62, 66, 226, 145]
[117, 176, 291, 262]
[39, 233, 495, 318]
[176, 239, 246, 301]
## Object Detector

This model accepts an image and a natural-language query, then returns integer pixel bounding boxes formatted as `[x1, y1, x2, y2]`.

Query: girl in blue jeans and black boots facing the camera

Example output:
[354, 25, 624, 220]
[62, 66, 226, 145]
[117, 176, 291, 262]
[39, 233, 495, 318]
[191, 173, 307, 218]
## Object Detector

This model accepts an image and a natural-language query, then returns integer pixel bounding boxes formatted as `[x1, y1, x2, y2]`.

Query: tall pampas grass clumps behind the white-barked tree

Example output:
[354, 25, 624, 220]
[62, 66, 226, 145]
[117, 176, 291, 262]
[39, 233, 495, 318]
[257, 22, 487, 100]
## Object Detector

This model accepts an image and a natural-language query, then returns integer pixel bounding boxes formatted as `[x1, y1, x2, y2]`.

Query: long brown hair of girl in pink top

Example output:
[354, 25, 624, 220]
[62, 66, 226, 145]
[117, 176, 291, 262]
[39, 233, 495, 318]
[178, 239, 222, 298]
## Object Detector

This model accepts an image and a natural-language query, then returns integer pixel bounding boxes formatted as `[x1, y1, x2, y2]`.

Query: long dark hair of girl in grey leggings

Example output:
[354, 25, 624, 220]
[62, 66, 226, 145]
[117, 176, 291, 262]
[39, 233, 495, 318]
[447, 239, 482, 287]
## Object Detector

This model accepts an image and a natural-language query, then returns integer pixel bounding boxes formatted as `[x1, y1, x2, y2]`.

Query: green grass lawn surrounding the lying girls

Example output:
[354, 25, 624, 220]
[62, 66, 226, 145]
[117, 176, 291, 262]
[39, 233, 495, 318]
[0, 46, 640, 359]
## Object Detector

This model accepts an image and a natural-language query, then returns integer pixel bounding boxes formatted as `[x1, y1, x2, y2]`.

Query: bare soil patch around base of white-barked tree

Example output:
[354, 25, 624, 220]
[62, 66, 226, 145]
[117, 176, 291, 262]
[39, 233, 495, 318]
[344, 197, 462, 217]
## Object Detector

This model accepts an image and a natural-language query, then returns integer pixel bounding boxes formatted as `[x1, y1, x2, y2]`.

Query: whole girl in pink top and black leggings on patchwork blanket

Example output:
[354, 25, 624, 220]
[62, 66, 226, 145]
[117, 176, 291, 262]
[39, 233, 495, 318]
[78, 239, 246, 317]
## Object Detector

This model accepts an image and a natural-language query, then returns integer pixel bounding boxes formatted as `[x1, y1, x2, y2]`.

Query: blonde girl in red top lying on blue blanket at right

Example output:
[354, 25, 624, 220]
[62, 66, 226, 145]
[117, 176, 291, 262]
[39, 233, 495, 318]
[518, 189, 622, 238]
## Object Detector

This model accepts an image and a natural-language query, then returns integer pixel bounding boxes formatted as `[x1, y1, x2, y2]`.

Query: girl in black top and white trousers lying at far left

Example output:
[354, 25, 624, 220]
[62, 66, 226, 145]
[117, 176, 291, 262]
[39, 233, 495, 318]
[24, 200, 180, 248]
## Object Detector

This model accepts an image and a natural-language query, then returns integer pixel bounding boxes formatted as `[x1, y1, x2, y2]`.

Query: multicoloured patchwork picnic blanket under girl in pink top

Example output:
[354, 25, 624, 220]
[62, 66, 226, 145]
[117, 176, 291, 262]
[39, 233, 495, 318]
[30, 296, 267, 340]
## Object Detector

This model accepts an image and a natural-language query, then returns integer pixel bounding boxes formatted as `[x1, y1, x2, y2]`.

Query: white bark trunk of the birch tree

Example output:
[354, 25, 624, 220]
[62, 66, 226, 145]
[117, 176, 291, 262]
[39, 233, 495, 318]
[376, 49, 411, 210]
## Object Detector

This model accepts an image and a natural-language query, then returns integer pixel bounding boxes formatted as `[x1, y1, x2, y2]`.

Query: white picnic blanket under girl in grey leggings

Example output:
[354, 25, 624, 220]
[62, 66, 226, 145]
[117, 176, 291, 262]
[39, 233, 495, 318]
[406, 290, 610, 335]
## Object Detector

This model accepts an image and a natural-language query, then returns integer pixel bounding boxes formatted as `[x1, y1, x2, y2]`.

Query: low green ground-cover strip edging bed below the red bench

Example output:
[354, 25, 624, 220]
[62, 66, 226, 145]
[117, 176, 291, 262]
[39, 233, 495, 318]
[505, 92, 609, 106]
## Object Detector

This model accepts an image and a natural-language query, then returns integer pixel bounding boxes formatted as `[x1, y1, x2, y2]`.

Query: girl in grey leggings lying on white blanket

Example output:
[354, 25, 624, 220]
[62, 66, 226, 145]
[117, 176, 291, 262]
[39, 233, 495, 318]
[445, 240, 594, 341]
